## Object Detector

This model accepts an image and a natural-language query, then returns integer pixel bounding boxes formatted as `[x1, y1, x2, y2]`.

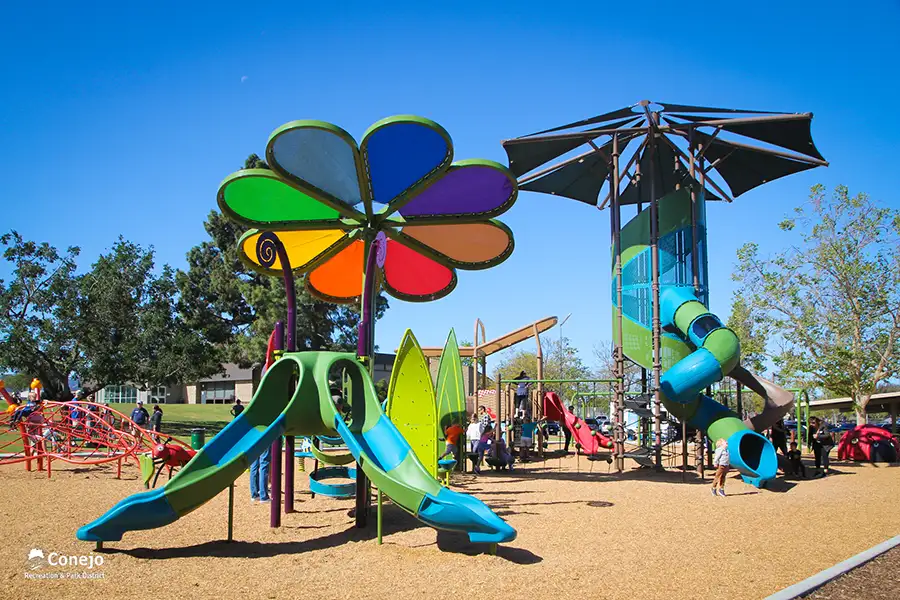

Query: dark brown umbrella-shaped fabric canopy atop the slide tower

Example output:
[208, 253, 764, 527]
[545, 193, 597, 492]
[503, 100, 828, 207]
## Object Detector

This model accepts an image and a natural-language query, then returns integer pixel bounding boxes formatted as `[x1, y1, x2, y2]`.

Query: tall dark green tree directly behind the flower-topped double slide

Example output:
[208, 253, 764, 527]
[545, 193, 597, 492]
[176, 154, 388, 375]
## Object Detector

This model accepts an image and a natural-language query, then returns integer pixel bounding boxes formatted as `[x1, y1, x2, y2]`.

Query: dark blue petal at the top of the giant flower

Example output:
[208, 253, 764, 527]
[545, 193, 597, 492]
[359, 115, 453, 204]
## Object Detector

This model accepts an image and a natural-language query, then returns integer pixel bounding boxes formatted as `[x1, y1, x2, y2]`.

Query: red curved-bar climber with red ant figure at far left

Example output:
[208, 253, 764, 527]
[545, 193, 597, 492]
[0, 400, 194, 484]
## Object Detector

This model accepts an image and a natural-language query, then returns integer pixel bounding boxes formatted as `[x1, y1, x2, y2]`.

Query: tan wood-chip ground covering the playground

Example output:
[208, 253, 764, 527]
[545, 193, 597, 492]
[0, 457, 900, 600]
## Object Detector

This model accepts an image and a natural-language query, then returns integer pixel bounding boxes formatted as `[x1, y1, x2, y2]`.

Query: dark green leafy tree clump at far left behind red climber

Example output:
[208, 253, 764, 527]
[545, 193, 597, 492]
[0, 231, 196, 400]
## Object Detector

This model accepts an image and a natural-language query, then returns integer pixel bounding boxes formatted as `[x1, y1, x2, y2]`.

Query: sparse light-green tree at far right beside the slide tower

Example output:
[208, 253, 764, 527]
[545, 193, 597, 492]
[734, 185, 900, 423]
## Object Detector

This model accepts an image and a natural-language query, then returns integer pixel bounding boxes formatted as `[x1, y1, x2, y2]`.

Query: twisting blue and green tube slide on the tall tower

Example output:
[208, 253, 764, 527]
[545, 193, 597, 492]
[660, 287, 778, 487]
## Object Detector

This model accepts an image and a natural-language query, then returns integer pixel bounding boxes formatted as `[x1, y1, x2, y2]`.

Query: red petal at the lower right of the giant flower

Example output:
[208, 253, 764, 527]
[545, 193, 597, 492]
[384, 239, 456, 302]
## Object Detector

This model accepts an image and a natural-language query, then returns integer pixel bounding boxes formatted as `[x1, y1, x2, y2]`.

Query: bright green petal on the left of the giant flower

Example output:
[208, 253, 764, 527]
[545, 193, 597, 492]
[218, 169, 340, 229]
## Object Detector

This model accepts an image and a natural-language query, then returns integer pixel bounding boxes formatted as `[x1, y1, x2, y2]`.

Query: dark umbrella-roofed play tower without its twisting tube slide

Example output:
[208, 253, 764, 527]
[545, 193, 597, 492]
[503, 100, 827, 482]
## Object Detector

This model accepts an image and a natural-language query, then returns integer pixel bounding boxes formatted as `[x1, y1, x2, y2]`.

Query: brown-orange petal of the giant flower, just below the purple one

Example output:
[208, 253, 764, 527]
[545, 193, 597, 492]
[393, 221, 514, 269]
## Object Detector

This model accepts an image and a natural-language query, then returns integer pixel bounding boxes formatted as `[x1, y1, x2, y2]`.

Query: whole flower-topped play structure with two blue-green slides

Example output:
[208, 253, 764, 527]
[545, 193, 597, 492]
[78, 116, 517, 550]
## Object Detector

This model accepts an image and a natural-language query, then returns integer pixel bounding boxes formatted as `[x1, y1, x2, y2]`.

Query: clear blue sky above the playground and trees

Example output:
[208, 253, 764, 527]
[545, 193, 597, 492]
[0, 1, 900, 372]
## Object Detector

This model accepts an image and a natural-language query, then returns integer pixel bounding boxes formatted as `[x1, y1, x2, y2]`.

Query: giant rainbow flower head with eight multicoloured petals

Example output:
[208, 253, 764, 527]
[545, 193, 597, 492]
[218, 116, 517, 303]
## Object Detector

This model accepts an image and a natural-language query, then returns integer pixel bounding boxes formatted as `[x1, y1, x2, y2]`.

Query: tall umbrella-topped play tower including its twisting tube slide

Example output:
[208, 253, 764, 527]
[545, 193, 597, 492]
[503, 100, 828, 486]
